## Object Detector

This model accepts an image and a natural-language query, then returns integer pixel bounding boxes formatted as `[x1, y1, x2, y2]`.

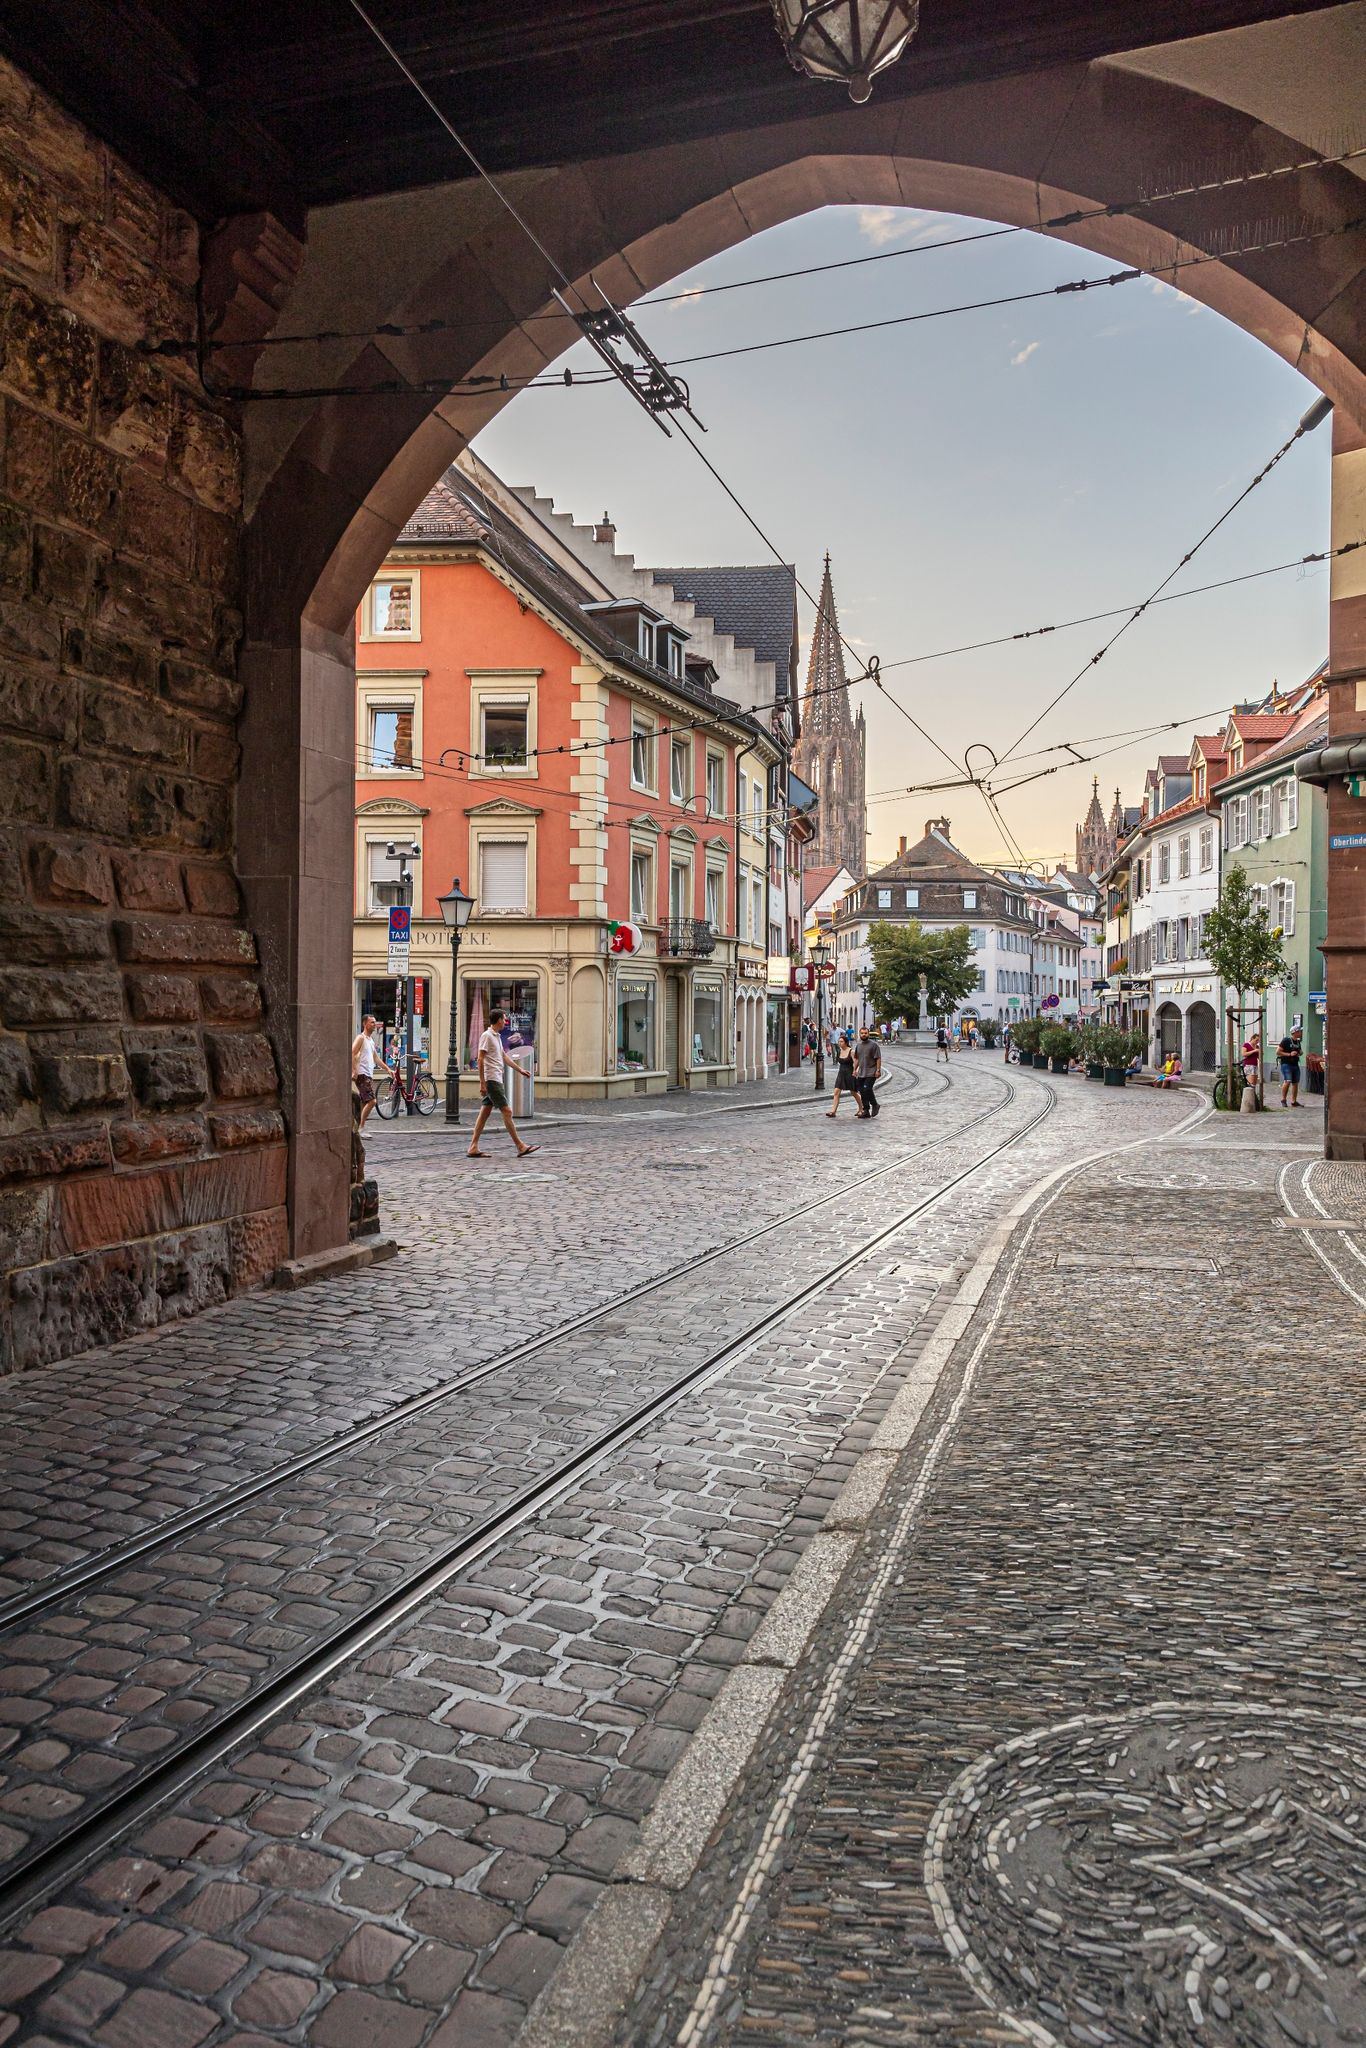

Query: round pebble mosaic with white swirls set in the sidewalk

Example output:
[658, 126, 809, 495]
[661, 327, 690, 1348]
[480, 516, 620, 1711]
[926, 1704, 1366, 2048]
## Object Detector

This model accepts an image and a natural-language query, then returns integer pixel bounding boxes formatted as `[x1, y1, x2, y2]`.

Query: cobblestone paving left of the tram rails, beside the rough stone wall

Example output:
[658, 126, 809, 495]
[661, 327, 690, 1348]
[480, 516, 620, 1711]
[0, 1061, 929, 1602]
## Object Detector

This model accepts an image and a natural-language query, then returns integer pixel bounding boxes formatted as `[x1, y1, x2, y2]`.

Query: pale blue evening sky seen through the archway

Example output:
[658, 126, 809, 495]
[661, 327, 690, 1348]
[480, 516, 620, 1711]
[477, 207, 1331, 866]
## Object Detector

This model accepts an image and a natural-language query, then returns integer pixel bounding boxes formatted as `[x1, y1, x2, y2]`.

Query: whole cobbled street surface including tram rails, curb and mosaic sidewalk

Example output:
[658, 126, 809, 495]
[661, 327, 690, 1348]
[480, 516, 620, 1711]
[0, 1049, 1366, 2048]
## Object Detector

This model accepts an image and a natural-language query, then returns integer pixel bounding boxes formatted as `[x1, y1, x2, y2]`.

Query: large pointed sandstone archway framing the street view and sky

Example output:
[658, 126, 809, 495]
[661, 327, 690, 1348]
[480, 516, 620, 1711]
[240, 8, 1366, 1251]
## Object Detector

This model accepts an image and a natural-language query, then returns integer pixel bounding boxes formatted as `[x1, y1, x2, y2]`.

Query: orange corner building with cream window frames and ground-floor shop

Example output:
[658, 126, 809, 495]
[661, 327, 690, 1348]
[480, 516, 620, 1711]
[354, 469, 786, 1098]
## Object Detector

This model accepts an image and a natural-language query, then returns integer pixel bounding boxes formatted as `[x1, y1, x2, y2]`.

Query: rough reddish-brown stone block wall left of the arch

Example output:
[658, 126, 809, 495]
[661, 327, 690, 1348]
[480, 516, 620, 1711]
[0, 63, 289, 1370]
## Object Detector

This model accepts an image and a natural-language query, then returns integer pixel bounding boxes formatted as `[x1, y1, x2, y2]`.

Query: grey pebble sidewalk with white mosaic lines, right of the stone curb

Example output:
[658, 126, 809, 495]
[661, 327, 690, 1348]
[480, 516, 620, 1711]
[616, 1116, 1366, 2048]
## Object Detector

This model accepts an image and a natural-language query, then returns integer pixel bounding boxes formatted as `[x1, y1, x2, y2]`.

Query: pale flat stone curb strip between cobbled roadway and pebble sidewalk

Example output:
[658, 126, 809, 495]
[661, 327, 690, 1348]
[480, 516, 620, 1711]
[512, 1090, 1212, 2048]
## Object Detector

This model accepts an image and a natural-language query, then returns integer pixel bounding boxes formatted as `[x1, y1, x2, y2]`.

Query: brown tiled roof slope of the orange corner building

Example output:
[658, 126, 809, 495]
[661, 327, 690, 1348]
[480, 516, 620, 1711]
[397, 465, 762, 733]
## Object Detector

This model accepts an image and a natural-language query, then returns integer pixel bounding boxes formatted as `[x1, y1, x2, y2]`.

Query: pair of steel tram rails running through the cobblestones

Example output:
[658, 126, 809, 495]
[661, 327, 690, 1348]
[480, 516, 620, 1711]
[0, 1075, 1057, 1925]
